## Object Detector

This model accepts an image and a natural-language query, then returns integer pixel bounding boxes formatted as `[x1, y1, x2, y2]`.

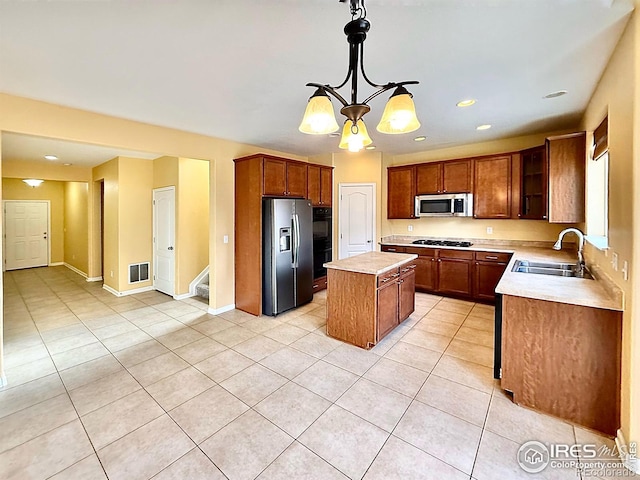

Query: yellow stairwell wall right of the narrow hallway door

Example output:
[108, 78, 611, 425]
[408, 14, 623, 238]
[176, 158, 210, 295]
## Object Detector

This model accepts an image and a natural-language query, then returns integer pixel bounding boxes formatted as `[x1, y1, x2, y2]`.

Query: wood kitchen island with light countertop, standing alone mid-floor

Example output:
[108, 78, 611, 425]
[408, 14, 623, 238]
[324, 252, 417, 349]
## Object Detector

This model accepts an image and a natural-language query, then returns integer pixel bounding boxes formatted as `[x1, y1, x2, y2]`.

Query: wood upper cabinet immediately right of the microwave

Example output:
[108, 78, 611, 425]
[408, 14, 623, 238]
[473, 155, 511, 218]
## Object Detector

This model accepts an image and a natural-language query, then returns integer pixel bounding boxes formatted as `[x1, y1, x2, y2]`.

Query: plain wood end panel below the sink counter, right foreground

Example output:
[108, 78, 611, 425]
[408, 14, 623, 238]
[501, 295, 622, 436]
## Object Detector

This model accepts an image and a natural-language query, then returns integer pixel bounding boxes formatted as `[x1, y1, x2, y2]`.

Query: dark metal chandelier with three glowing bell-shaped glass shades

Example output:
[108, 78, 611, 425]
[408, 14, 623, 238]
[299, 0, 420, 152]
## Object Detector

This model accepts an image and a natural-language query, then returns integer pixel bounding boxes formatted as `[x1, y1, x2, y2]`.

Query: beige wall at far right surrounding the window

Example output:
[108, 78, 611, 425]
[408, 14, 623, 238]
[582, 5, 640, 441]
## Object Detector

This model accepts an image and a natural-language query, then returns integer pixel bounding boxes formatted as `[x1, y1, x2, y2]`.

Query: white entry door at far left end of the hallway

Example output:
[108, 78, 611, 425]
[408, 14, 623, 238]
[4, 201, 49, 270]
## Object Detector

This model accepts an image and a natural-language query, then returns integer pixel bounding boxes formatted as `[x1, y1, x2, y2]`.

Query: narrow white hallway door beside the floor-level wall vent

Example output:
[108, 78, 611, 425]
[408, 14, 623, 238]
[153, 187, 176, 296]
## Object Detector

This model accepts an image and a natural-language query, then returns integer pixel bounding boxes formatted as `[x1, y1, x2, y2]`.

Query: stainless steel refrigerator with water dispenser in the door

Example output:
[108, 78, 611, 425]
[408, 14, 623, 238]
[262, 198, 313, 316]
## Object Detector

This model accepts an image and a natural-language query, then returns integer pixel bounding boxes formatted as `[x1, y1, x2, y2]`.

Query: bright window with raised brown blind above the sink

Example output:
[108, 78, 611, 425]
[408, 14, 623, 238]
[587, 117, 609, 249]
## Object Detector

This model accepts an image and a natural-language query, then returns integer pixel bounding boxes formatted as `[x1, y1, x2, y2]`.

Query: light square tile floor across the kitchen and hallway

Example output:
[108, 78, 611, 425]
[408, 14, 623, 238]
[0, 267, 624, 480]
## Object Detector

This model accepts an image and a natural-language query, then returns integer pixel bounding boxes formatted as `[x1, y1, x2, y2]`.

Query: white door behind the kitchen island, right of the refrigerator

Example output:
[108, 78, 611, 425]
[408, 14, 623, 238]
[338, 183, 376, 258]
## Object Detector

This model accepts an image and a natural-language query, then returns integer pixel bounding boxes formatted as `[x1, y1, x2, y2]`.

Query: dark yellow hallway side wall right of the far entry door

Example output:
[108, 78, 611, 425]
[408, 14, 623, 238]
[64, 182, 89, 275]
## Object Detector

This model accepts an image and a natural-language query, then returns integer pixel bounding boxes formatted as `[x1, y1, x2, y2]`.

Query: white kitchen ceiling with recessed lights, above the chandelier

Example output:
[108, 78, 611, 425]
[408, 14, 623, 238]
[0, 0, 632, 156]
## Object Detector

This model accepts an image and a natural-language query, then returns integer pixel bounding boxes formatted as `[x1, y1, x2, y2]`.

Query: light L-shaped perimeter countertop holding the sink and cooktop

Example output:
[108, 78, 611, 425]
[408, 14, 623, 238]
[380, 236, 624, 311]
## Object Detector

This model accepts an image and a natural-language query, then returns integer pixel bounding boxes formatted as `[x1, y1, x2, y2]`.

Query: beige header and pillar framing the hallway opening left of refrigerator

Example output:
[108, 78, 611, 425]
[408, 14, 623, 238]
[0, 94, 307, 310]
